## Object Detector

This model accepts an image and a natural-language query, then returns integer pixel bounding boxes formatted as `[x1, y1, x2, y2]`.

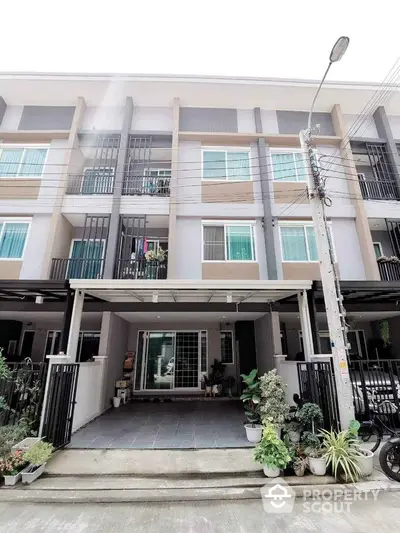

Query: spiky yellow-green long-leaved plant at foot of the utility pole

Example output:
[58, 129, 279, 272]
[321, 429, 361, 483]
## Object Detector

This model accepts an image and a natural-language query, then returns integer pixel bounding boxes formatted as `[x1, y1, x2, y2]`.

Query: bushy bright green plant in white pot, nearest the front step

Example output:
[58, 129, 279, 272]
[254, 424, 291, 477]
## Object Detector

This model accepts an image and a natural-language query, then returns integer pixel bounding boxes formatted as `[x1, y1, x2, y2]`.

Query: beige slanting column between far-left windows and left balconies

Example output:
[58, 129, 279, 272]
[40, 96, 86, 279]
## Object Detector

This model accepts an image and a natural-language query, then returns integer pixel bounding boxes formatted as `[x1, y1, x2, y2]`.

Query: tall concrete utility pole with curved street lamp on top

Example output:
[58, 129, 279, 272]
[299, 37, 354, 429]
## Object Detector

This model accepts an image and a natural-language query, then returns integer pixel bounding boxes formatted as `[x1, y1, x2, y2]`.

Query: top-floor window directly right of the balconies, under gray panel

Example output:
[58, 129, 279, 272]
[203, 150, 251, 181]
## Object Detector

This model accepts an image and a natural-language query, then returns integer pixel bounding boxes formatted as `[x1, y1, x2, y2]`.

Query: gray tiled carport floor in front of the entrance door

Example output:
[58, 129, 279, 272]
[69, 399, 251, 449]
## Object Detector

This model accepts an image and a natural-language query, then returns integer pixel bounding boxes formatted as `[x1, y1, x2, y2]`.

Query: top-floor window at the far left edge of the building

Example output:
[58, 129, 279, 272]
[0, 146, 47, 178]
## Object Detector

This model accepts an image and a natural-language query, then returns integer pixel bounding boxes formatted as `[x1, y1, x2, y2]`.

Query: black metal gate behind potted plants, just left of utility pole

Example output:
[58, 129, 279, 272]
[297, 361, 340, 430]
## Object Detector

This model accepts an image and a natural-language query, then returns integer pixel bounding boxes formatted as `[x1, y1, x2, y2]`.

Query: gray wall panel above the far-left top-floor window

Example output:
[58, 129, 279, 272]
[18, 105, 75, 130]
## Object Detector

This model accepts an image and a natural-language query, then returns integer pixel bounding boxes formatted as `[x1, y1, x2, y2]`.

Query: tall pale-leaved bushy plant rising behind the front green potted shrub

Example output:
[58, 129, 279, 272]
[260, 369, 290, 435]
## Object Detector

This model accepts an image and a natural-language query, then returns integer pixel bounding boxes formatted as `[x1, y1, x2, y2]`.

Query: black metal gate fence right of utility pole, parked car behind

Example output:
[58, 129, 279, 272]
[349, 359, 400, 429]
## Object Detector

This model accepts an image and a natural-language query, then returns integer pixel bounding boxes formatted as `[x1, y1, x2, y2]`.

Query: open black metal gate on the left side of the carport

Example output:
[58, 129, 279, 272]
[42, 363, 79, 449]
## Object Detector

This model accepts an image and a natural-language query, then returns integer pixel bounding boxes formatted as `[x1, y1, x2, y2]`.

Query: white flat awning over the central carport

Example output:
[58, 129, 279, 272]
[70, 279, 312, 304]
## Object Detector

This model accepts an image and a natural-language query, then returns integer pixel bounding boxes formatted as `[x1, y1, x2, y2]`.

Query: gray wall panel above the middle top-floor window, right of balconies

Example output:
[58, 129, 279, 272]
[179, 107, 238, 133]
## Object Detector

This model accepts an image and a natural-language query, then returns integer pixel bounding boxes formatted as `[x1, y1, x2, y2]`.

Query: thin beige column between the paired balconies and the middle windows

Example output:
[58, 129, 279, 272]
[167, 98, 180, 279]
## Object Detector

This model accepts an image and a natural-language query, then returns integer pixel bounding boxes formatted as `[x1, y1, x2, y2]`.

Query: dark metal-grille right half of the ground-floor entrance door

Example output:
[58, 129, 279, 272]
[175, 331, 199, 389]
